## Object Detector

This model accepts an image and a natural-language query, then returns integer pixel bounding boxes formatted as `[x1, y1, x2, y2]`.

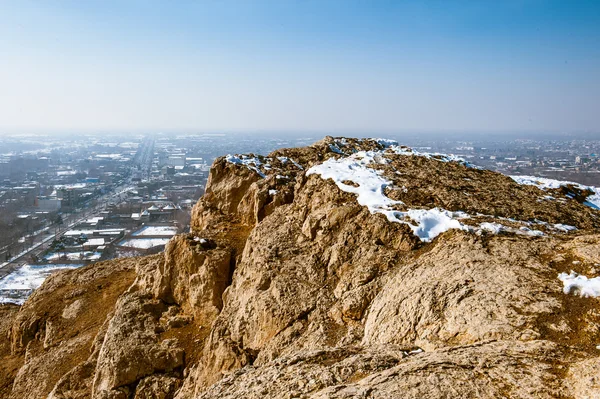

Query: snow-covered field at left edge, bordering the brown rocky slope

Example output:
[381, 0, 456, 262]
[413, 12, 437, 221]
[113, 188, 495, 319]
[0, 264, 83, 305]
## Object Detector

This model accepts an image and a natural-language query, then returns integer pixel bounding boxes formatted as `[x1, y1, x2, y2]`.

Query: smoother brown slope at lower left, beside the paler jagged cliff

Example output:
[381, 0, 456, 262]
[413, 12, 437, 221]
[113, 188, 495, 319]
[0, 257, 138, 399]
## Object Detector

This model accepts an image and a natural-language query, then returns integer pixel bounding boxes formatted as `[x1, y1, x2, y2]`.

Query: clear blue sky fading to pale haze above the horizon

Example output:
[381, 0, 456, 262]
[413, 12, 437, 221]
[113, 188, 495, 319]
[0, 0, 600, 134]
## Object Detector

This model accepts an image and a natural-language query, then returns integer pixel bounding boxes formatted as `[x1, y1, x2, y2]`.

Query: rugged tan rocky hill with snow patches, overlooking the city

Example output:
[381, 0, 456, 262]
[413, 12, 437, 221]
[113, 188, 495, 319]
[0, 137, 600, 399]
